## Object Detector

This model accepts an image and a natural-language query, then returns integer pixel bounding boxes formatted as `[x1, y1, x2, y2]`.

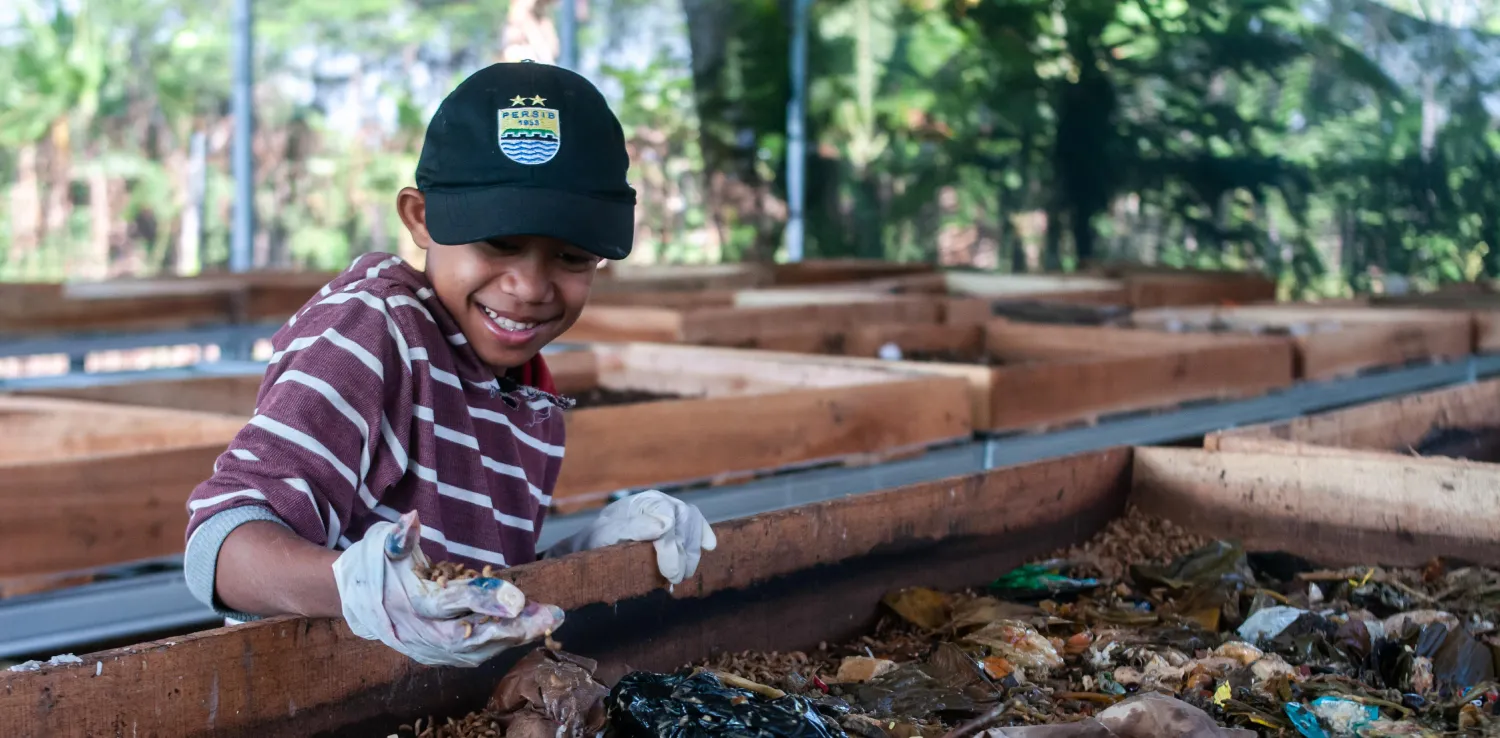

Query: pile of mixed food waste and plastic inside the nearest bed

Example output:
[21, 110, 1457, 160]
[398, 512, 1500, 738]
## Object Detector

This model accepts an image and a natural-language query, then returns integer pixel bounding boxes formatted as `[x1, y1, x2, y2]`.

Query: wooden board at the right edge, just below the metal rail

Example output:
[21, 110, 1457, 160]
[1203, 380, 1500, 453]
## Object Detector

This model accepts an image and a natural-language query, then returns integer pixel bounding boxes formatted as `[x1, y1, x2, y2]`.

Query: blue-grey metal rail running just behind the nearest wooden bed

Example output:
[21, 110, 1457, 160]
[0, 356, 1500, 659]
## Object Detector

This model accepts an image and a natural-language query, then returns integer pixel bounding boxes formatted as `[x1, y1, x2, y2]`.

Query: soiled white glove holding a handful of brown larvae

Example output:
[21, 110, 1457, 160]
[333, 512, 563, 666]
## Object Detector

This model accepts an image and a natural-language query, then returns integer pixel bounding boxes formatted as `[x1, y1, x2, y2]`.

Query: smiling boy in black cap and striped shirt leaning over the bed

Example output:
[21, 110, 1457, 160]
[186, 63, 714, 666]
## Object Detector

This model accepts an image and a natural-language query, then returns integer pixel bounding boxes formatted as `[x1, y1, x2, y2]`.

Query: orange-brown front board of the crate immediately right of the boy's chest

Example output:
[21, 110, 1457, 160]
[552, 377, 974, 512]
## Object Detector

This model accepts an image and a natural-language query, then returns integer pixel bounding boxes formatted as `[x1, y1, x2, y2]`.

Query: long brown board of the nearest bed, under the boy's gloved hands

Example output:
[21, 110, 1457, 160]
[0, 449, 1130, 738]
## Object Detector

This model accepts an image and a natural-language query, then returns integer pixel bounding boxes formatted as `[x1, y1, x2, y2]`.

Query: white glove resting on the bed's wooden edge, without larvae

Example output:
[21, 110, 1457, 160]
[548, 489, 719, 584]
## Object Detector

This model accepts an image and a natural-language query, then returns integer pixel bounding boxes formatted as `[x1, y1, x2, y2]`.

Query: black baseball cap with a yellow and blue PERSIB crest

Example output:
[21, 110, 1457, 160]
[417, 62, 636, 260]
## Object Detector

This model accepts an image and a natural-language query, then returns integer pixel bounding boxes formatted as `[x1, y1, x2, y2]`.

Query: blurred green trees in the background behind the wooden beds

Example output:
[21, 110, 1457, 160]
[0, 0, 1500, 296]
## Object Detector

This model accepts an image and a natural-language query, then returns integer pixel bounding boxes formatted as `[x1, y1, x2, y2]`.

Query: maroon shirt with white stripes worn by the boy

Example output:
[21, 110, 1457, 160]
[186, 254, 564, 618]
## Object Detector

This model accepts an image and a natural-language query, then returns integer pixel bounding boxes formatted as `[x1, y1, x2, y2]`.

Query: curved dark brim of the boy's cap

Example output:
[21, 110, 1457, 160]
[425, 186, 636, 260]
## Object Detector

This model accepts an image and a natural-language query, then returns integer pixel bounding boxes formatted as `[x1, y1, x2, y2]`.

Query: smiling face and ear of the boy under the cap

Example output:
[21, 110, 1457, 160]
[398, 188, 600, 374]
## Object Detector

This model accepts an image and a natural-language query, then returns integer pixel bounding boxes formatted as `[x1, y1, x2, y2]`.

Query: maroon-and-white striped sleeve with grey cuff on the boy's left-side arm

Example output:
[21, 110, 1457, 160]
[185, 291, 414, 618]
